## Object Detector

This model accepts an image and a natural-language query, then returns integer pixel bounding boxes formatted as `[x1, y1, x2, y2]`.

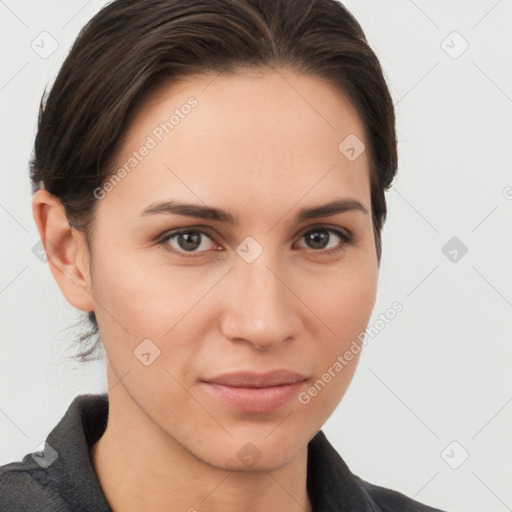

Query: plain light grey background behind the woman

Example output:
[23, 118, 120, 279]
[0, 0, 512, 512]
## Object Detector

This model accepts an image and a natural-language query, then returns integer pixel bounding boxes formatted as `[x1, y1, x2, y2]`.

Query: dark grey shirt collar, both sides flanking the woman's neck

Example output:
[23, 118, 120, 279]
[47, 393, 379, 512]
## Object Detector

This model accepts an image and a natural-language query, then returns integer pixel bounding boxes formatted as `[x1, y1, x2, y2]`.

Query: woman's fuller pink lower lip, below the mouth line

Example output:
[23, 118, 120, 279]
[204, 381, 305, 413]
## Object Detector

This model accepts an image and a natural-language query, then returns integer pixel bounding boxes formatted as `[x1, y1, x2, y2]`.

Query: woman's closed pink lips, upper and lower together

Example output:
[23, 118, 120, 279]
[203, 369, 307, 413]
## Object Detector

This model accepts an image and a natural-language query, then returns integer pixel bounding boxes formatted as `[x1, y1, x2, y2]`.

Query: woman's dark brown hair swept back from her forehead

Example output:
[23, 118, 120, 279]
[30, 0, 397, 361]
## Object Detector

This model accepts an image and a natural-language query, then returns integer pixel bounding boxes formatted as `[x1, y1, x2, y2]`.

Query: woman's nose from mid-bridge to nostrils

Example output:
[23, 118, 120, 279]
[222, 256, 300, 350]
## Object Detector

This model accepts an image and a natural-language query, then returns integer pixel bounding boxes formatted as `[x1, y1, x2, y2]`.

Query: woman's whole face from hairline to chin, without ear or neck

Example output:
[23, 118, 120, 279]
[87, 71, 378, 471]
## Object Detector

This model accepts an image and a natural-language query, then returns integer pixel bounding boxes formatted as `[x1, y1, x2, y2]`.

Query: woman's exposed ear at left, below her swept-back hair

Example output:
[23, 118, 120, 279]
[32, 190, 95, 311]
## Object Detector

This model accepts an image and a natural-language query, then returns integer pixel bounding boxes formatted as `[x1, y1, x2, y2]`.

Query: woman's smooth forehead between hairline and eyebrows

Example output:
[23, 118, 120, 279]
[98, 70, 369, 218]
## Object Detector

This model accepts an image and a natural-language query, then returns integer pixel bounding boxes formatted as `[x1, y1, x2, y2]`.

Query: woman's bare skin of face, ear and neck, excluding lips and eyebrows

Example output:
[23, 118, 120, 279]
[33, 70, 378, 512]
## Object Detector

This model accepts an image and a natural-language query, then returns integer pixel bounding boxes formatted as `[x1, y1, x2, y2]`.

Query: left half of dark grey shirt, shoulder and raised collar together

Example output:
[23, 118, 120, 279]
[0, 394, 110, 512]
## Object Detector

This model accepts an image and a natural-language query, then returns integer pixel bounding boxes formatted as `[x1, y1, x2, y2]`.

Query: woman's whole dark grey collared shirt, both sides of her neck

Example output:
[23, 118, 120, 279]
[0, 393, 448, 512]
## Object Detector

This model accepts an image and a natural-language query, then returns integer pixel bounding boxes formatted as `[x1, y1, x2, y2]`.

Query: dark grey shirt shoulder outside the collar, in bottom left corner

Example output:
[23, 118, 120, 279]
[0, 454, 69, 512]
